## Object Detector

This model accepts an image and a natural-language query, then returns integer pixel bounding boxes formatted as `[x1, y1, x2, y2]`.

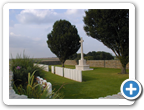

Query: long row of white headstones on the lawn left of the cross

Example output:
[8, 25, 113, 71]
[51, 66, 82, 82]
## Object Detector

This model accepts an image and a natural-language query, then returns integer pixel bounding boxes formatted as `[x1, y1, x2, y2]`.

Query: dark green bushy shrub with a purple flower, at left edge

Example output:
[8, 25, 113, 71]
[10, 53, 43, 88]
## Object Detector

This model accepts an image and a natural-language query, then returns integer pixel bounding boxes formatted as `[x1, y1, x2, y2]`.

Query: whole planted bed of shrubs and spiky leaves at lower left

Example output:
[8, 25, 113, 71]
[10, 54, 59, 99]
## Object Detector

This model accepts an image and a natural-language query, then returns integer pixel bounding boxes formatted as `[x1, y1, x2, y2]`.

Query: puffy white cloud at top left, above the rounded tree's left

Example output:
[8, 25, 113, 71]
[17, 9, 58, 24]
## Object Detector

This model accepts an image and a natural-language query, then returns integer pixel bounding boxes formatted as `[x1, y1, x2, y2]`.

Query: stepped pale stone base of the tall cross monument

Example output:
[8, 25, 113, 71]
[75, 59, 93, 71]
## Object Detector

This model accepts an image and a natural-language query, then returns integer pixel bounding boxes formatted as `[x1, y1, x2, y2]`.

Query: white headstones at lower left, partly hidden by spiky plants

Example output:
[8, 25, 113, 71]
[36, 76, 52, 97]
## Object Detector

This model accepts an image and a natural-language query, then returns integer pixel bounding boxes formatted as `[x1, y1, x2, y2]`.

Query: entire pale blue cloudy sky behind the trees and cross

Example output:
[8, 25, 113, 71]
[9, 9, 114, 58]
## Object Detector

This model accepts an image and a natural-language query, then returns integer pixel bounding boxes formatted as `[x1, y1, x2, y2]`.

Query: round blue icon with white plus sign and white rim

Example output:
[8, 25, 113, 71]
[121, 79, 141, 100]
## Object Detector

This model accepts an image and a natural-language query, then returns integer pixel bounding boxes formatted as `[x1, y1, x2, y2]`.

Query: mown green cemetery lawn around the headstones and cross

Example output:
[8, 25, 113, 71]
[40, 65, 129, 99]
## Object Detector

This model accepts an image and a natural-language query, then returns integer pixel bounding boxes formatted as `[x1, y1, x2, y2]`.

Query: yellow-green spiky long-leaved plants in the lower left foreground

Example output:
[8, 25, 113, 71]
[13, 71, 62, 99]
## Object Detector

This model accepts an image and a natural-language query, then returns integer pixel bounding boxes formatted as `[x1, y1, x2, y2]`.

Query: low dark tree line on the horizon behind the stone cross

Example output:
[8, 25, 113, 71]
[68, 51, 114, 61]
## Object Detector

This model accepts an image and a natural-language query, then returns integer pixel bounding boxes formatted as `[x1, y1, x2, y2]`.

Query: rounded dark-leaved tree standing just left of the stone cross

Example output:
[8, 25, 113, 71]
[47, 20, 80, 67]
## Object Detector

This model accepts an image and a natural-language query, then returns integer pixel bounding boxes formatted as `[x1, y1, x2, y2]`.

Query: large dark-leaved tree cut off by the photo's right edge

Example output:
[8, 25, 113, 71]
[83, 9, 129, 74]
